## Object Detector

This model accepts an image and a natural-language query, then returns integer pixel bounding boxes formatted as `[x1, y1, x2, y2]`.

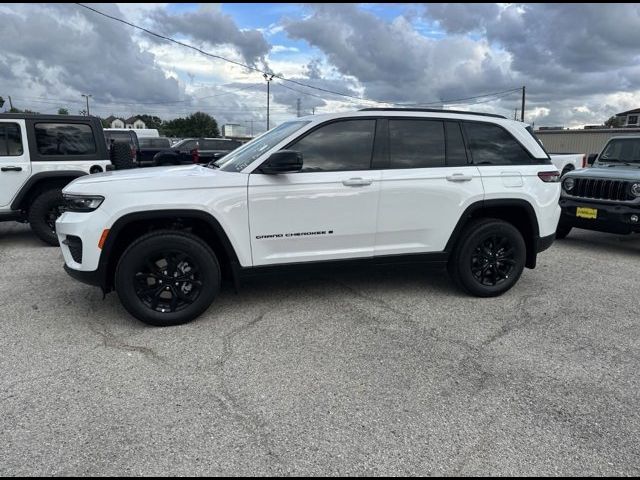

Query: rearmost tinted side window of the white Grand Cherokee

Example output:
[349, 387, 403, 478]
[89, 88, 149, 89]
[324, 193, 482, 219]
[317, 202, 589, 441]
[464, 122, 533, 165]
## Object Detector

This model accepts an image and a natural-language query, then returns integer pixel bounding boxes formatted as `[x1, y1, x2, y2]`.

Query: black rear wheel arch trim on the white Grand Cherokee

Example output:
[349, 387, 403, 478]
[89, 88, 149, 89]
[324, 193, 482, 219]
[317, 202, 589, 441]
[445, 199, 540, 268]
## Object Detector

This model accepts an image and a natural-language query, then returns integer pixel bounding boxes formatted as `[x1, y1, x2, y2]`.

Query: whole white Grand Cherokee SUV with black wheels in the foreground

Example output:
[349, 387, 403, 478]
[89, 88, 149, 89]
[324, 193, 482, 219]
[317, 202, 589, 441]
[57, 109, 560, 325]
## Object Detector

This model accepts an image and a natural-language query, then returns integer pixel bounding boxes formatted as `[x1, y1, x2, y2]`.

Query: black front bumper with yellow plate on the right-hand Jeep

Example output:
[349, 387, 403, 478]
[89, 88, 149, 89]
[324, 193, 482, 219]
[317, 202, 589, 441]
[558, 198, 640, 234]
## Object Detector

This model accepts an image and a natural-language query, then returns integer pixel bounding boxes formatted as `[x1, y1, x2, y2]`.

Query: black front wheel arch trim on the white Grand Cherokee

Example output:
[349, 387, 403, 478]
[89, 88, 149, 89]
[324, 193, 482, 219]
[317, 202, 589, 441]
[98, 210, 240, 292]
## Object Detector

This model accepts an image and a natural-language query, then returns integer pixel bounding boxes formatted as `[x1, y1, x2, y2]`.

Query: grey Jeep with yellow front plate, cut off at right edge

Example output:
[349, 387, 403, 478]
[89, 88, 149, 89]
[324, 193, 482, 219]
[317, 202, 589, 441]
[556, 136, 640, 239]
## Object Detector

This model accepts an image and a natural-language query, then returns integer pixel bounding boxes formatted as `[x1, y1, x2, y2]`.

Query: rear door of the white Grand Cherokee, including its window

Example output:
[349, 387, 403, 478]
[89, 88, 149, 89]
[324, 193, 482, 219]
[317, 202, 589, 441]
[375, 118, 484, 255]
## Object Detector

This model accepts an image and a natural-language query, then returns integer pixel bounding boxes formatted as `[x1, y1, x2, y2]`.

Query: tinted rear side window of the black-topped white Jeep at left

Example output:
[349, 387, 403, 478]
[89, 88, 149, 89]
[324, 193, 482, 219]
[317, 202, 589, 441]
[34, 123, 96, 155]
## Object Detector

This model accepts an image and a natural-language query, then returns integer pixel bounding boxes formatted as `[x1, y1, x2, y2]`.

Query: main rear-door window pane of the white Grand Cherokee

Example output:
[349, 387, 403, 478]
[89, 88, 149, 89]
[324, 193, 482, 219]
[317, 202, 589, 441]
[389, 119, 445, 168]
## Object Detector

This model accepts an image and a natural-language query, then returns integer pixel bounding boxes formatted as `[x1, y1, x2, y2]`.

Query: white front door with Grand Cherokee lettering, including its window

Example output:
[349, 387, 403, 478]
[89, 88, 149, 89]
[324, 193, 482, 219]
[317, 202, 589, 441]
[248, 119, 381, 266]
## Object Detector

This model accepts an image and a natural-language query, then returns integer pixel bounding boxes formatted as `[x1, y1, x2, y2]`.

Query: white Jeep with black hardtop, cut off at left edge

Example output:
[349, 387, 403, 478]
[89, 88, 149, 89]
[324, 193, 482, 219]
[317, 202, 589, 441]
[0, 113, 111, 245]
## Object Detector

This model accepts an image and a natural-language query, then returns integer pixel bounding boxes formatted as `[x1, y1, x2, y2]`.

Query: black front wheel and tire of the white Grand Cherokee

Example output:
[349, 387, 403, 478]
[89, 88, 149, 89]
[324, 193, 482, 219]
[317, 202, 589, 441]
[115, 230, 221, 327]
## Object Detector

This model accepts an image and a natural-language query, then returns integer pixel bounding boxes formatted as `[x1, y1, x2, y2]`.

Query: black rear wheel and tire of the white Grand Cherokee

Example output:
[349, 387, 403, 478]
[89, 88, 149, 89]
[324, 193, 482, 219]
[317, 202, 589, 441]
[449, 218, 527, 297]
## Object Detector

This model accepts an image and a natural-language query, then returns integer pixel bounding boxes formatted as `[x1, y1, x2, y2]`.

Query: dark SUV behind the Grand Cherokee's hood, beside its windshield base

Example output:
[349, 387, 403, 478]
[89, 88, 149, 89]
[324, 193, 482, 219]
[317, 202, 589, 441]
[153, 138, 241, 165]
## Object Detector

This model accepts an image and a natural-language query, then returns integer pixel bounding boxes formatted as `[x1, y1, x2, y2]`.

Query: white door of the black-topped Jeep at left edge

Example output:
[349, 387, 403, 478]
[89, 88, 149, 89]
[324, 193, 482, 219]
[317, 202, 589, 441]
[0, 120, 31, 209]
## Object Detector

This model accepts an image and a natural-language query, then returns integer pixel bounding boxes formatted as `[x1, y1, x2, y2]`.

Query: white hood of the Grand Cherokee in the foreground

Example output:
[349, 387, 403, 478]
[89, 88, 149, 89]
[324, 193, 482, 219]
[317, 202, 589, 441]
[63, 165, 247, 195]
